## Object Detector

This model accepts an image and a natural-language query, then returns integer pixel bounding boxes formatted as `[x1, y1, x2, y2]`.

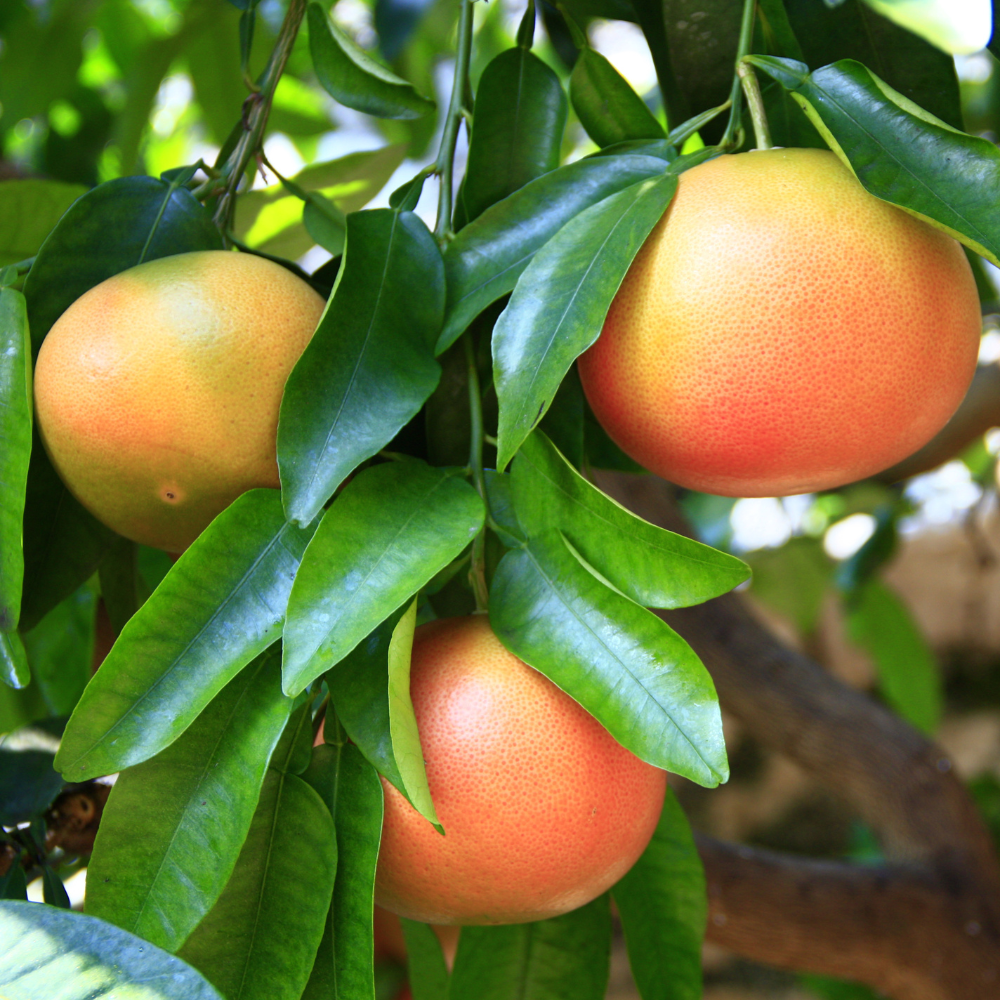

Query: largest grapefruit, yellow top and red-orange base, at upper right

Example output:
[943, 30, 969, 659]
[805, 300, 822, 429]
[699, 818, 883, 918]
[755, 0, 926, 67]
[580, 149, 981, 496]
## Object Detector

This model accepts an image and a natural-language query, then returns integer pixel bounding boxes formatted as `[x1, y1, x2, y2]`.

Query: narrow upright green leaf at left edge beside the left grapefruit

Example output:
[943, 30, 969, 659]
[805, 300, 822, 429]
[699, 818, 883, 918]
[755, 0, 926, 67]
[0, 288, 32, 644]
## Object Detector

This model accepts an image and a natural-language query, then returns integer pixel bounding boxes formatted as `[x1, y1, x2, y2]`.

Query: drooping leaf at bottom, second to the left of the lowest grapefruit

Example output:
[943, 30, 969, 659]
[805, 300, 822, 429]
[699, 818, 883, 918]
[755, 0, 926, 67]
[180, 768, 337, 1000]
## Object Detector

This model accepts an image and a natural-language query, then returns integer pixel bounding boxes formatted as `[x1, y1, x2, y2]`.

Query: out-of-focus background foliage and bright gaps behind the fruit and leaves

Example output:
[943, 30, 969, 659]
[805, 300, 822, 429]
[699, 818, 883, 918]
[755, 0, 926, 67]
[0, 0, 1000, 1000]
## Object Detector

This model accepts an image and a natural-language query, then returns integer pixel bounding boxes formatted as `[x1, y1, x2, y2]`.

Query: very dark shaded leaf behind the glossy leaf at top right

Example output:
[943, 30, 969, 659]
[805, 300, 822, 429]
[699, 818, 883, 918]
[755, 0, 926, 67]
[788, 0, 962, 128]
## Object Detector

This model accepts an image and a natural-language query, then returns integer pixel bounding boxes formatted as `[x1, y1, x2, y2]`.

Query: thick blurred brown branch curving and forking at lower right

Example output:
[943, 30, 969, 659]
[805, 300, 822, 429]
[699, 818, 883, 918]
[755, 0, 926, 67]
[599, 473, 1000, 1000]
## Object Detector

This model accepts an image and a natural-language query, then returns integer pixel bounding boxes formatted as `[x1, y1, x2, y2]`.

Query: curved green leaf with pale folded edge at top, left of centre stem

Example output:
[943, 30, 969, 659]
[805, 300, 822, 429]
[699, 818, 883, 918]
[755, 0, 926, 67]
[307, 3, 434, 119]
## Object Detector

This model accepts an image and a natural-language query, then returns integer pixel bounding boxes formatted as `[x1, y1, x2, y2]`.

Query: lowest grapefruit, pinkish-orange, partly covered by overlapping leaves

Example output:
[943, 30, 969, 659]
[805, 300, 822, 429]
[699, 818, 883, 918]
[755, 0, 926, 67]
[375, 615, 666, 924]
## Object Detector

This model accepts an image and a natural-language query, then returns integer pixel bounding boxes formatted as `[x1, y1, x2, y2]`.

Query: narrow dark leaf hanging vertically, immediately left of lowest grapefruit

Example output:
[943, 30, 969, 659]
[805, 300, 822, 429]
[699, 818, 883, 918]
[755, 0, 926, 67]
[302, 740, 382, 1000]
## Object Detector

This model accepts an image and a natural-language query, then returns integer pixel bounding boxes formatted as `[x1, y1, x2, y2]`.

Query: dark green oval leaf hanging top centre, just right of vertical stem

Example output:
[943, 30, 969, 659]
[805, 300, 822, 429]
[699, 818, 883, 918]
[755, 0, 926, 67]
[462, 46, 567, 221]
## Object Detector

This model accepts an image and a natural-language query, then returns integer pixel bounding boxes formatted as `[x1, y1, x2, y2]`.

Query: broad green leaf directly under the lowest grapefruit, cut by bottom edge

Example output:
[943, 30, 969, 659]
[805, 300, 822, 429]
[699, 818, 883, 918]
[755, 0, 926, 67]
[448, 893, 611, 1000]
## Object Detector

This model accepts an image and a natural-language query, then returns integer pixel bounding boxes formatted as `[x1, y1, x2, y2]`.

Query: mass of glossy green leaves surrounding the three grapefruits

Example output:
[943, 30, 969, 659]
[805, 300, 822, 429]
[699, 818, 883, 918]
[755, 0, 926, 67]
[0, 0, 1000, 1000]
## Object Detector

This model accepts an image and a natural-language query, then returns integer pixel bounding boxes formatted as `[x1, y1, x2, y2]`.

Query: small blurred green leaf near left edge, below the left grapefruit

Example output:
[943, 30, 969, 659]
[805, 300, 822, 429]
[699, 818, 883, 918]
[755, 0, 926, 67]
[21, 584, 97, 716]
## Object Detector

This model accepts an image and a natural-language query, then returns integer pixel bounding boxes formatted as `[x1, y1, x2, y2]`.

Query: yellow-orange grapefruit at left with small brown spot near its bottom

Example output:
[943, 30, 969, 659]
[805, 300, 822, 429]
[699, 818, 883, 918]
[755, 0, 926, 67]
[35, 250, 323, 552]
